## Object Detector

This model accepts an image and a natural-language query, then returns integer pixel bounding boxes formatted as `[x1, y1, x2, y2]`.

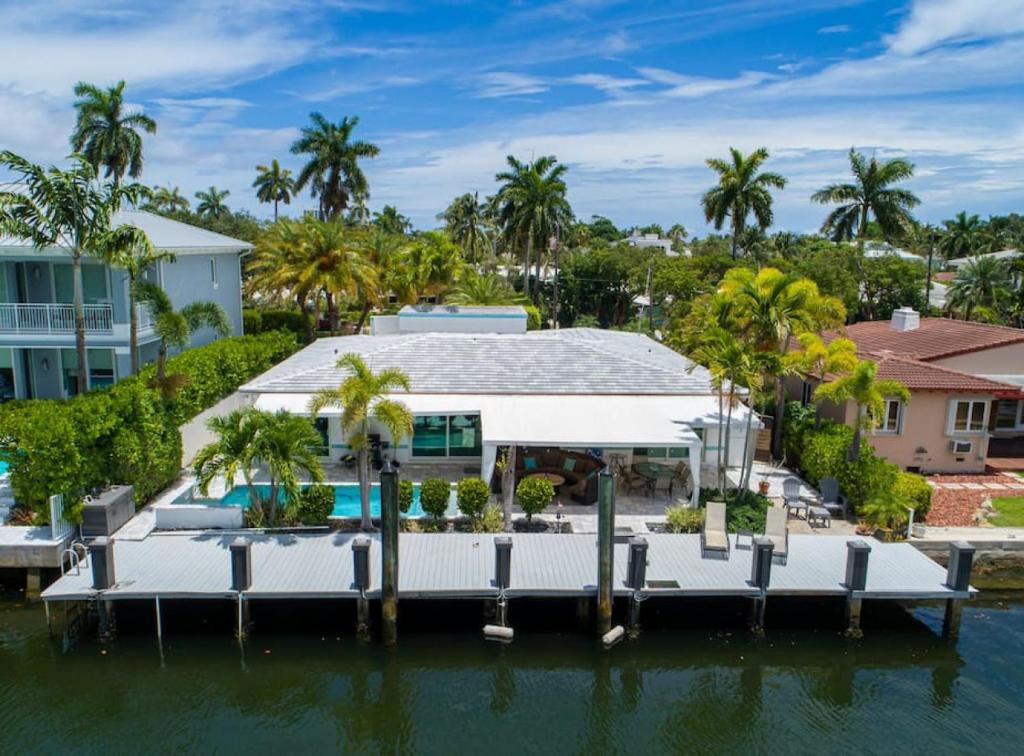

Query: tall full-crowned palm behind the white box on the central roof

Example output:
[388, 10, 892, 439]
[495, 155, 572, 301]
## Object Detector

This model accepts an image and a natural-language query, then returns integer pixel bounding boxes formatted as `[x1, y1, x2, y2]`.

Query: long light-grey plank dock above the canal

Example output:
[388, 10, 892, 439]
[42, 531, 974, 601]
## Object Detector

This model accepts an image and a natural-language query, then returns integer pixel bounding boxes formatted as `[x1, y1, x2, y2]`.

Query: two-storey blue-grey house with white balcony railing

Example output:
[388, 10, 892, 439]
[0, 205, 252, 402]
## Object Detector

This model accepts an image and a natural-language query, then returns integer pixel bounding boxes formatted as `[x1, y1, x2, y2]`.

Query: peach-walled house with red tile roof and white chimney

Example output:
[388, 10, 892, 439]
[790, 307, 1024, 473]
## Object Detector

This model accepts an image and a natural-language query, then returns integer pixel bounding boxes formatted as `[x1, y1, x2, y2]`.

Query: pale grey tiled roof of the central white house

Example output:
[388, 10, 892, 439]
[243, 328, 712, 394]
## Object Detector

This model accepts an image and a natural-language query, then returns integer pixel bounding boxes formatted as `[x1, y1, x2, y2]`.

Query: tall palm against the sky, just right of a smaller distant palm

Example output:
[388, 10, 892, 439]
[292, 113, 380, 220]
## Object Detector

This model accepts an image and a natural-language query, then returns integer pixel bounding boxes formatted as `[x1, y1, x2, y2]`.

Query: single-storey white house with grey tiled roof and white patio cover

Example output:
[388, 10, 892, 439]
[241, 307, 760, 501]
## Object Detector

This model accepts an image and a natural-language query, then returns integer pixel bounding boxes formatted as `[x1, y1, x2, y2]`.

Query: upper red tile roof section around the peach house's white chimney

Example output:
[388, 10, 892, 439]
[846, 318, 1024, 361]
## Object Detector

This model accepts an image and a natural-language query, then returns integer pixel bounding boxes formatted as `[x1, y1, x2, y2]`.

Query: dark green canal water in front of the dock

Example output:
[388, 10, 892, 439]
[0, 593, 1024, 755]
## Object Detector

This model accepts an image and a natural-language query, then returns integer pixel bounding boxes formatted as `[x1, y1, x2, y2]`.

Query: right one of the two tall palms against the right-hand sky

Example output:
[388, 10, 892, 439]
[811, 148, 921, 243]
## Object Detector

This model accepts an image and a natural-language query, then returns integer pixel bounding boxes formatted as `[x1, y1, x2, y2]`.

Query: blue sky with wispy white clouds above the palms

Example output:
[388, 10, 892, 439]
[0, 0, 1024, 235]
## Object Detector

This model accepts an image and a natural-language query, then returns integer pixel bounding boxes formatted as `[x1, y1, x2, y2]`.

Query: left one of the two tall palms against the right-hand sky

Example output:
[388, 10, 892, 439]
[700, 148, 785, 259]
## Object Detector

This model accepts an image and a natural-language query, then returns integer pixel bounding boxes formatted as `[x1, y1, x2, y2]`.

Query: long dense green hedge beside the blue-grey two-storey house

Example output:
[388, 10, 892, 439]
[0, 333, 296, 521]
